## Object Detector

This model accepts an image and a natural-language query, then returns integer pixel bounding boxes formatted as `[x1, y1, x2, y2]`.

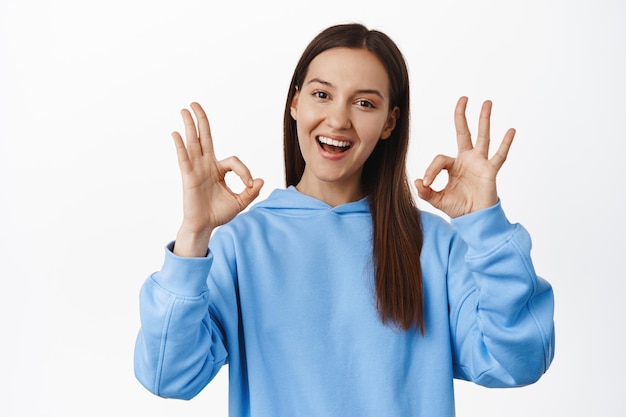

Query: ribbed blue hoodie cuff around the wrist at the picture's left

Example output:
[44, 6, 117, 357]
[153, 242, 213, 297]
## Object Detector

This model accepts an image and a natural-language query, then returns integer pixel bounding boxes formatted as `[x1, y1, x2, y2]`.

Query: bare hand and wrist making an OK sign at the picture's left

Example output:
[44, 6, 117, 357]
[172, 103, 263, 257]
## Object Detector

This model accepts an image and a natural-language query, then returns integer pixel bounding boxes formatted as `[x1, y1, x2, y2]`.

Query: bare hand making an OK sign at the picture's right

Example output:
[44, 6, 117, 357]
[415, 97, 515, 218]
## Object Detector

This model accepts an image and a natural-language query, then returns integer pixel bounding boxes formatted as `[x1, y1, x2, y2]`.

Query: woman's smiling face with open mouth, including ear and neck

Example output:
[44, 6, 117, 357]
[291, 48, 399, 201]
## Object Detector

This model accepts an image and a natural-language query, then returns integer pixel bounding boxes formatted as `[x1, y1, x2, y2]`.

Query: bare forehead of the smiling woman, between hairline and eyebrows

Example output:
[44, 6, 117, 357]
[304, 48, 389, 93]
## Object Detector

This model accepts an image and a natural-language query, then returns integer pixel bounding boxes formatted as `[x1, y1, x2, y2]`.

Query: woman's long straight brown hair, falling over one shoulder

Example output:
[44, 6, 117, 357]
[283, 24, 425, 333]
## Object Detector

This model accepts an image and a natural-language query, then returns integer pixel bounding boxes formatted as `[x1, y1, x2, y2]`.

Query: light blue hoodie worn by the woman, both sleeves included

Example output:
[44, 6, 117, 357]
[135, 187, 554, 417]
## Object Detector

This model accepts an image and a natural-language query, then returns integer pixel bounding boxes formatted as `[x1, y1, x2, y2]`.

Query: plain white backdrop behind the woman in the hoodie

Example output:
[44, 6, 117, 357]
[0, 0, 626, 417]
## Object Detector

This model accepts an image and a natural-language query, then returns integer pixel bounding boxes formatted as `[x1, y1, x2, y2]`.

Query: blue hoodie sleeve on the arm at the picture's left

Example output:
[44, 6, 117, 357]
[135, 243, 228, 399]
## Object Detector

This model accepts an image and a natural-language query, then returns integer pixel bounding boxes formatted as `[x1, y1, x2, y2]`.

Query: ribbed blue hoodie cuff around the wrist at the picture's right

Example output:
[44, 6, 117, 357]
[451, 200, 518, 257]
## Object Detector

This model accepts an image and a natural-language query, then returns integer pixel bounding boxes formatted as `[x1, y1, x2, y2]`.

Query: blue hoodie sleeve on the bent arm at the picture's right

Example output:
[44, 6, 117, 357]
[448, 202, 554, 387]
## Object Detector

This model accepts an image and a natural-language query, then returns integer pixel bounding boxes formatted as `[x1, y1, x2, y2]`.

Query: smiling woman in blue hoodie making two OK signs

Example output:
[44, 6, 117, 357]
[135, 25, 554, 416]
